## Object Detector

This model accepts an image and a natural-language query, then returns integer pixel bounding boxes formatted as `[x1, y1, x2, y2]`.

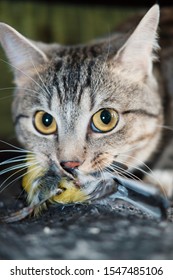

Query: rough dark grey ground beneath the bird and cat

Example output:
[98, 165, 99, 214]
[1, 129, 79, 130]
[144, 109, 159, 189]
[0, 177, 173, 260]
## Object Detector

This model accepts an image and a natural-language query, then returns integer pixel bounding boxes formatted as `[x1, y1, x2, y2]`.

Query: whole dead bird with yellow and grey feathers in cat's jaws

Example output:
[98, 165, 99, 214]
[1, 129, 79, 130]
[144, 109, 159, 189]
[1, 158, 169, 223]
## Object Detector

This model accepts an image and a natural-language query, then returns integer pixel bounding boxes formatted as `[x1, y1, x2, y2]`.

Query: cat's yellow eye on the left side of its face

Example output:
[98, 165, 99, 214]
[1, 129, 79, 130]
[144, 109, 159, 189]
[34, 111, 57, 135]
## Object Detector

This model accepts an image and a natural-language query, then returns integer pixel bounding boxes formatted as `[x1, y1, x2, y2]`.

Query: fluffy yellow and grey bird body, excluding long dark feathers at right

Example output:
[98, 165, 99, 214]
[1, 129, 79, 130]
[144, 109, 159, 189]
[4, 156, 130, 222]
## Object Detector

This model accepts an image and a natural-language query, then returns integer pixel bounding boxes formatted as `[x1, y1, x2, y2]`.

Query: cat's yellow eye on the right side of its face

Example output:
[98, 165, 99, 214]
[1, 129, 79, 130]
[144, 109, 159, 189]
[91, 109, 119, 133]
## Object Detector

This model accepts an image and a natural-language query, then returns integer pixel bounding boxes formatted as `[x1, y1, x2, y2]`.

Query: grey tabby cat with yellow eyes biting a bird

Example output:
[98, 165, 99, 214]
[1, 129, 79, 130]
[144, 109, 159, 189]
[0, 4, 173, 218]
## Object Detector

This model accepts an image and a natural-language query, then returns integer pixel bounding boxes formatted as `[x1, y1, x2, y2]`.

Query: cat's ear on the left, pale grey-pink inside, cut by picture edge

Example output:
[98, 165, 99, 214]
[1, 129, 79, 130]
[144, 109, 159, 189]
[0, 23, 48, 83]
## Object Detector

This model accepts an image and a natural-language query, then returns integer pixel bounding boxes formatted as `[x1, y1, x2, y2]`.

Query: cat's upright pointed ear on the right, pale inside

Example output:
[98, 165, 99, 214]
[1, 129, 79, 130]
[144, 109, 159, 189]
[116, 4, 160, 79]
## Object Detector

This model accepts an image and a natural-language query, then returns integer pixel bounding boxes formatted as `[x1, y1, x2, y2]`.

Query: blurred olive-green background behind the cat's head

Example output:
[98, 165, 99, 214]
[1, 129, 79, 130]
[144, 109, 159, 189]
[0, 0, 173, 142]
